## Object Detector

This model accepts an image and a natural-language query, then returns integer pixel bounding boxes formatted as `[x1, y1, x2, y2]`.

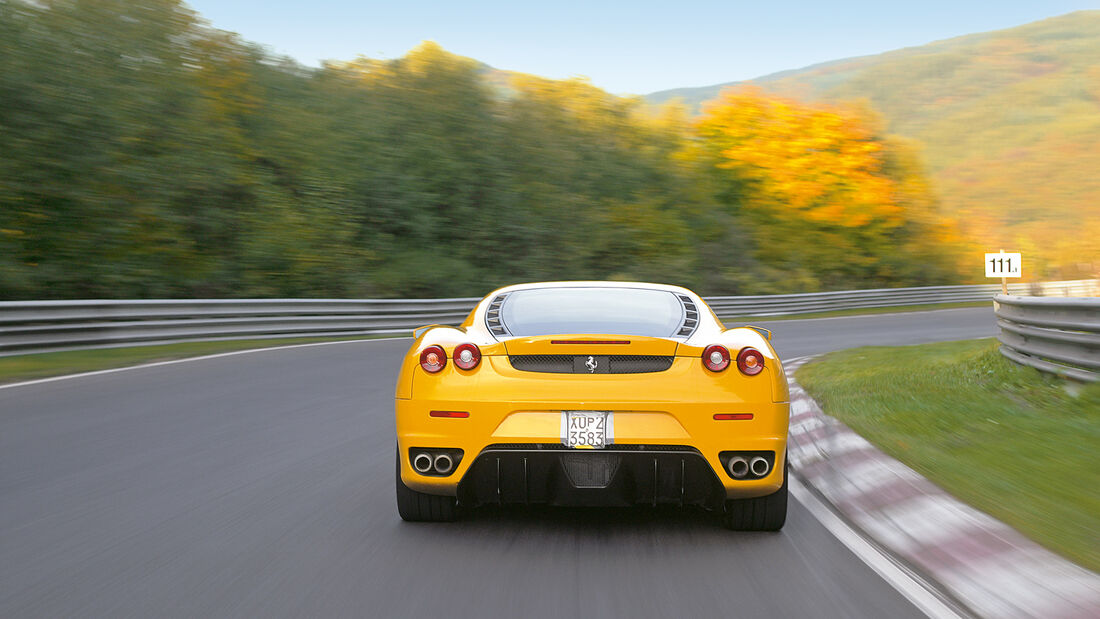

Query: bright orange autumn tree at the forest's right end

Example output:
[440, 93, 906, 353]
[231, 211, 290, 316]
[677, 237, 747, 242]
[696, 87, 953, 289]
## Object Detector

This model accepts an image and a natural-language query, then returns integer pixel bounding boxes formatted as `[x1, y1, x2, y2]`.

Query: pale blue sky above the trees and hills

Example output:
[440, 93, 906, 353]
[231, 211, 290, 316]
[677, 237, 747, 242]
[188, 0, 1100, 95]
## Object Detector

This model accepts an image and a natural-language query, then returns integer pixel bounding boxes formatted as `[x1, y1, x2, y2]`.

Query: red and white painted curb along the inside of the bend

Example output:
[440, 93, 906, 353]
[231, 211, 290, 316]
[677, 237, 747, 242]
[784, 357, 1100, 619]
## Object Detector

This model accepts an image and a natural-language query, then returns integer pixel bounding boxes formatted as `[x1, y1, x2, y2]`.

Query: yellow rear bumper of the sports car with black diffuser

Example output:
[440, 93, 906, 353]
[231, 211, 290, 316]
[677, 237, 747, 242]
[396, 399, 790, 506]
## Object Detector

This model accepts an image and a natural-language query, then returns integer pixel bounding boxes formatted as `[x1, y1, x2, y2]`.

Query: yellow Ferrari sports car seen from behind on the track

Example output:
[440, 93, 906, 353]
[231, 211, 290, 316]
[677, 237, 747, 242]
[395, 281, 790, 531]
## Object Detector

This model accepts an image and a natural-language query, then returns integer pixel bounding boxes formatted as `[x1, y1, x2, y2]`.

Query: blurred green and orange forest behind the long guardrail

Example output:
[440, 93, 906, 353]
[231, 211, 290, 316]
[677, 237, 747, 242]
[0, 0, 963, 300]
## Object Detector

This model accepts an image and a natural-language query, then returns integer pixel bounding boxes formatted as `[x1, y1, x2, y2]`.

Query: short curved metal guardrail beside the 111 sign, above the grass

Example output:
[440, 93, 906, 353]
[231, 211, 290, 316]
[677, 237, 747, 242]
[993, 295, 1100, 382]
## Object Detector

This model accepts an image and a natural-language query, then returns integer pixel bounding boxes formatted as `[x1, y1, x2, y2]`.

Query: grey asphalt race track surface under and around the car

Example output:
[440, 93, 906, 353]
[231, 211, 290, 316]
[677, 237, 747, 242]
[0, 308, 996, 619]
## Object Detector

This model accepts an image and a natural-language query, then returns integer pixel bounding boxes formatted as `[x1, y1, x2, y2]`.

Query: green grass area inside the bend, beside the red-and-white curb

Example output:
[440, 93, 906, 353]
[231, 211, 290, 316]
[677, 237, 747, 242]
[795, 340, 1100, 571]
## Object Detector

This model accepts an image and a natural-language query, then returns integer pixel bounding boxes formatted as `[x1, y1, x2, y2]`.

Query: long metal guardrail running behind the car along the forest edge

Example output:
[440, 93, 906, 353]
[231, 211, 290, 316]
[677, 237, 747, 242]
[0, 279, 1100, 356]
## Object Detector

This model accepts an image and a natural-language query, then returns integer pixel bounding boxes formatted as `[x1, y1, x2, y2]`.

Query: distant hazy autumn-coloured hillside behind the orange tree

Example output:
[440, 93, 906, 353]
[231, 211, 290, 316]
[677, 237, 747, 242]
[647, 11, 1100, 277]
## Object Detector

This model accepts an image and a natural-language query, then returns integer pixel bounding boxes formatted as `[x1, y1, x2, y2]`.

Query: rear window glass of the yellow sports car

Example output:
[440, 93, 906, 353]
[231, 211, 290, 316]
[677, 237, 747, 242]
[501, 288, 683, 338]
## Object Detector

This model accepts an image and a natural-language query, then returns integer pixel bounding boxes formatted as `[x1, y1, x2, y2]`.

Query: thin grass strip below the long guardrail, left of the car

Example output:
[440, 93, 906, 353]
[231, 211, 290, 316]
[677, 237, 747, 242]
[0, 334, 404, 384]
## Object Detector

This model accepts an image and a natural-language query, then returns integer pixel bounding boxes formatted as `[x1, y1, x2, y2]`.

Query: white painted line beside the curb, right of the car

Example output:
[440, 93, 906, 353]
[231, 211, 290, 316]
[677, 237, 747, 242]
[788, 475, 965, 619]
